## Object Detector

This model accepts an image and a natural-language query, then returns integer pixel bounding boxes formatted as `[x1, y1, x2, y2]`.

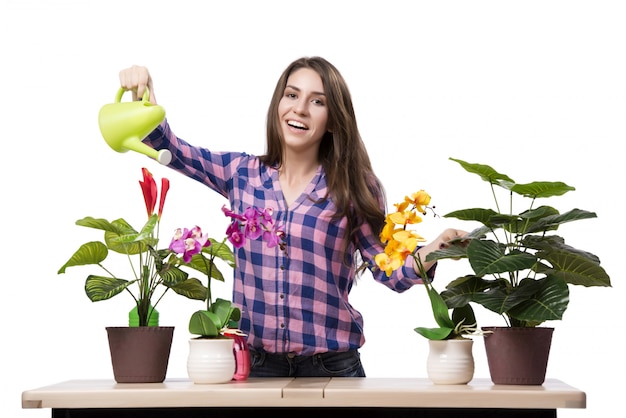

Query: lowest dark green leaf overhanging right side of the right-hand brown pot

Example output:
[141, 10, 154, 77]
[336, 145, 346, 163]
[509, 276, 569, 322]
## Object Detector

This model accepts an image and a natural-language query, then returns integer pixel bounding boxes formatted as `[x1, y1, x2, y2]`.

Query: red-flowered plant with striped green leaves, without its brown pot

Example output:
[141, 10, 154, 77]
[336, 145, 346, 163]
[58, 168, 207, 326]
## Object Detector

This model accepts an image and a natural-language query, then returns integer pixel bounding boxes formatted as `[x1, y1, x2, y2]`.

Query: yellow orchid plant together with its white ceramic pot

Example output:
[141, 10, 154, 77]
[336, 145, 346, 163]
[375, 190, 477, 384]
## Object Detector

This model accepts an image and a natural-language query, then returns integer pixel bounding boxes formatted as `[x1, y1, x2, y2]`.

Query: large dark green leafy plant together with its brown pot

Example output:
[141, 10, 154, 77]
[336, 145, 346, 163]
[426, 158, 611, 384]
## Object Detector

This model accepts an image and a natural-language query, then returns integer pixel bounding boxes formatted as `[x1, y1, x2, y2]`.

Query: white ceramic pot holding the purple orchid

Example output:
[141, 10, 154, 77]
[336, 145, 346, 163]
[187, 338, 235, 384]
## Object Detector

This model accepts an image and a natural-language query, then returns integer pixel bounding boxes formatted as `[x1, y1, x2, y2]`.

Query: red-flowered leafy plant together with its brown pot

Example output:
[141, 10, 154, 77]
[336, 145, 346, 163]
[58, 168, 206, 383]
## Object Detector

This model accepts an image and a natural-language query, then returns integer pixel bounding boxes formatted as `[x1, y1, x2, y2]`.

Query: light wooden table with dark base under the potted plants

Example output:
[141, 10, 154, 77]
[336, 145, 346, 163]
[22, 377, 586, 418]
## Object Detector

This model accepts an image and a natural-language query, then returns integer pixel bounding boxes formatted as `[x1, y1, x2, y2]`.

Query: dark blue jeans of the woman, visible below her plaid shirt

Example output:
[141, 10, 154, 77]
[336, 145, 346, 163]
[250, 348, 365, 377]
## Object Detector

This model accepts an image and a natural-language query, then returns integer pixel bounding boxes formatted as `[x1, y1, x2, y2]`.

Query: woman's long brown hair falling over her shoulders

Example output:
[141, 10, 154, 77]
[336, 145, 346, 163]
[260, 57, 386, 259]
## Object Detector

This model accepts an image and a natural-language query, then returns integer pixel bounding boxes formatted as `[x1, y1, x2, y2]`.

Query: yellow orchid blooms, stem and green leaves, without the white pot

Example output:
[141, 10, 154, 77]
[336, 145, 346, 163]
[374, 190, 477, 340]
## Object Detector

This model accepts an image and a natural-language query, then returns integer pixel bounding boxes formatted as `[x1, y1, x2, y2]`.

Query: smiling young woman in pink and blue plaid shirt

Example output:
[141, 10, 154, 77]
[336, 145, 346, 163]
[120, 57, 464, 377]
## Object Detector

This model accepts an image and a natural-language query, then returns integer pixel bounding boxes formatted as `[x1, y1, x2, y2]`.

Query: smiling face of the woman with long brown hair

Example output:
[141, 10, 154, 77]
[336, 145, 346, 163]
[278, 68, 328, 152]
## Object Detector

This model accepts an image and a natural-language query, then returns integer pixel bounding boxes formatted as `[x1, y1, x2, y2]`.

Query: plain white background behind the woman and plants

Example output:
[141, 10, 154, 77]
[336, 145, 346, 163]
[0, 0, 626, 418]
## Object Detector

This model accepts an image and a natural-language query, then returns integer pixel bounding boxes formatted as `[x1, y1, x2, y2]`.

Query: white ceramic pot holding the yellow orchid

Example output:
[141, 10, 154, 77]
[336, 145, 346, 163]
[426, 338, 474, 385]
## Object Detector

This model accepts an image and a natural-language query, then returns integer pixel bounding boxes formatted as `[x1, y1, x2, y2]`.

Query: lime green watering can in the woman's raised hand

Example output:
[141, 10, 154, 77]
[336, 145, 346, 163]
[98, 88, 172, 165]
